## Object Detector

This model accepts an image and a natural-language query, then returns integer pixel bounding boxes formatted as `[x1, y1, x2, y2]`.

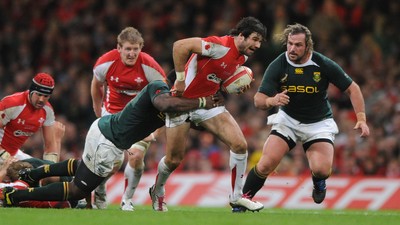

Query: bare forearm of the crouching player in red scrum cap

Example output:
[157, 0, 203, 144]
[42, 121, 65, 162]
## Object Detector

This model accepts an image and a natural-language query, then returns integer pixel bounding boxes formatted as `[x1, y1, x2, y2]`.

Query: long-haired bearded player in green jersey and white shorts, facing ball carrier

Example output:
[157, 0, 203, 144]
[236, 24, 369, 210]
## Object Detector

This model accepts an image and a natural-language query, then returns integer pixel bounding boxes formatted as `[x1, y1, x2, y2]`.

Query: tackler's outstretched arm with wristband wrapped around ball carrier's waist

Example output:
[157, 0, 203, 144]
[153, 93, 224, 112]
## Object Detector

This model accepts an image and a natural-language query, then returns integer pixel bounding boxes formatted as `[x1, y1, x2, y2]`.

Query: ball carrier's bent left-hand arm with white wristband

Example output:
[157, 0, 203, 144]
[172, 37, 202, 96]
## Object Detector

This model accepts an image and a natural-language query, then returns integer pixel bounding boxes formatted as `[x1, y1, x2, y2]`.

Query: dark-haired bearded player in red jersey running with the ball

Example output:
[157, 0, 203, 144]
[149, 17, 266, 211]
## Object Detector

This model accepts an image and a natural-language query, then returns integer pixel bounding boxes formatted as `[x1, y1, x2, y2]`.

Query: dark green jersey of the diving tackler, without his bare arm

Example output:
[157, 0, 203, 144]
[99, 80, 170, 149]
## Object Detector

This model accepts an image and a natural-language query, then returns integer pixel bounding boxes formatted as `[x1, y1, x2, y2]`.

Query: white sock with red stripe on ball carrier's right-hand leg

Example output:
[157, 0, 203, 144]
[229, 151, 247, 201]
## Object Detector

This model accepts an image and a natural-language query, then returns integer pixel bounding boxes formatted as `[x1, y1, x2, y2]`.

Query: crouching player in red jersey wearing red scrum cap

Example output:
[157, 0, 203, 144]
[0, 73, 63, 162]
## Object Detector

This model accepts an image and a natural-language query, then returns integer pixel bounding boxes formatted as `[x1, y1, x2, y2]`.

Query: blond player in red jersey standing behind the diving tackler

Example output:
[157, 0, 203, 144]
[91, 27, 166, 211]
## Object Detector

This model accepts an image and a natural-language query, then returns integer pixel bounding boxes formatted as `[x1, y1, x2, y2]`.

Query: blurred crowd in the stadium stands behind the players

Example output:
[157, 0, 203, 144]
[0, 0, 400, 207]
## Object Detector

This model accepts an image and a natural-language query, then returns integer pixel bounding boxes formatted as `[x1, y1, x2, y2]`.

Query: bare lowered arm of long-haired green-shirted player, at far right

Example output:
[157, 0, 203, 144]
[345, 81, 369, 137]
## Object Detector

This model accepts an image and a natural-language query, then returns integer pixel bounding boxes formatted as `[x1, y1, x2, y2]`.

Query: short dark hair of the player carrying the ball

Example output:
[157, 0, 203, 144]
[229, 16, 267, 40]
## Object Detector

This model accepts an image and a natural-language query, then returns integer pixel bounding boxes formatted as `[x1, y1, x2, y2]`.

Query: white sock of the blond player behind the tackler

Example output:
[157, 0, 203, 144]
[122, 163, 144, 200]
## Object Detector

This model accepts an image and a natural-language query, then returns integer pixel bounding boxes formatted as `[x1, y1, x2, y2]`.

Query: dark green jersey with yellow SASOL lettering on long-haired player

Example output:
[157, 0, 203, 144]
[258, 52, 353, 123]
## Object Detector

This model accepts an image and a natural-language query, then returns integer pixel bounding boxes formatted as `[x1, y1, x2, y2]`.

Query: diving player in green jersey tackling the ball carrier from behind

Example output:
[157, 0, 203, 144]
[0, 80, 223, 206]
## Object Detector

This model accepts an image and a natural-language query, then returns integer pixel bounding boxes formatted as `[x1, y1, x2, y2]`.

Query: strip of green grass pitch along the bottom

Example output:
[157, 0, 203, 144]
[0, 205, 400, 225]
